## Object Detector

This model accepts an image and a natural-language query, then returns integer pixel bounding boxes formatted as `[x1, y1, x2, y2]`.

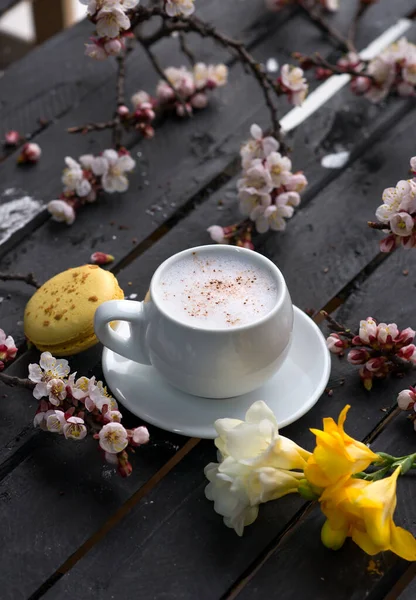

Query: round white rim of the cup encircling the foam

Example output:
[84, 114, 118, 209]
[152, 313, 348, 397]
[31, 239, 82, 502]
[150, 244, 288, 334]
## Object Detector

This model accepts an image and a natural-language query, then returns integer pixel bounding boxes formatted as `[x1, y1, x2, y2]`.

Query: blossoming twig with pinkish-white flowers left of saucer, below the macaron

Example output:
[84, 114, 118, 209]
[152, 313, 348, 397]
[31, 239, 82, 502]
[0, 338, 149, 477]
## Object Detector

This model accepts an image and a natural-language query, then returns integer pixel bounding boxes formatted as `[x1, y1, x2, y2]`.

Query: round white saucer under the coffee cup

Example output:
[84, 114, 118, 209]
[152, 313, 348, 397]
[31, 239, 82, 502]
[103, 307, 331, 439]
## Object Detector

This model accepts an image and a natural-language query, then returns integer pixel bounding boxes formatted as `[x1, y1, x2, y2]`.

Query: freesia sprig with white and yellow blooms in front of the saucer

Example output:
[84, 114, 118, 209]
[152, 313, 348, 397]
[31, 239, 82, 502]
[205, 401, 416, 560]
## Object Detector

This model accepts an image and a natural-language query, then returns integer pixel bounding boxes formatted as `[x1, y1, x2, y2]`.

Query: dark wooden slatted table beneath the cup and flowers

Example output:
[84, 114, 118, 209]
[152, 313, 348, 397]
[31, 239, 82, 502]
[0, 0, 416, 600]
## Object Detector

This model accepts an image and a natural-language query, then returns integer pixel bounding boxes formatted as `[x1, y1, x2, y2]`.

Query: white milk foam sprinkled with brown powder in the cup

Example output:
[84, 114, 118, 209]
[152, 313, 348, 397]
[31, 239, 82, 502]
[160, 252, 277, 329]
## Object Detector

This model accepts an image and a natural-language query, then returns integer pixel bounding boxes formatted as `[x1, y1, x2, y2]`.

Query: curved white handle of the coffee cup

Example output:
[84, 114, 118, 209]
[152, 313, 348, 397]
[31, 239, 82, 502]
[94, 300, 151, 365]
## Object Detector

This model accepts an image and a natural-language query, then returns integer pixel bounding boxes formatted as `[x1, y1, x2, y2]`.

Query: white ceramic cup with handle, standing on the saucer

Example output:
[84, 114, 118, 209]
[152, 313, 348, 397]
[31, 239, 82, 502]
[95, 245, 293, 398]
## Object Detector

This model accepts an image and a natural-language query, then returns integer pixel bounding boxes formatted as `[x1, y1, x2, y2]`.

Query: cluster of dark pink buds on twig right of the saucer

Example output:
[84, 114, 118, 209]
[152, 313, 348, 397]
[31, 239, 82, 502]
[322, 311, 416, 390]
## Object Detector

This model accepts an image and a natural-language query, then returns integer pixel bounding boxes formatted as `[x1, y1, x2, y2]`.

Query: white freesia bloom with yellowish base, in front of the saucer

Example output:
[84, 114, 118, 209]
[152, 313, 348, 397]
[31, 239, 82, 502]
[205, 401, 310, 535]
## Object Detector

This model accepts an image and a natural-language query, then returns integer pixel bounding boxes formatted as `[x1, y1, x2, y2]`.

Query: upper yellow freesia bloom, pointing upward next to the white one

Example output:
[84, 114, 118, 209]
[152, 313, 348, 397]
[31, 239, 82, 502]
[305, 405, 379, 488]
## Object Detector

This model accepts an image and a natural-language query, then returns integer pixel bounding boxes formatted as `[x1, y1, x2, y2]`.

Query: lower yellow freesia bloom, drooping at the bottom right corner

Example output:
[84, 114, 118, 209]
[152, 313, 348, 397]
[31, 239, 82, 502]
[320, 467, 416, 561]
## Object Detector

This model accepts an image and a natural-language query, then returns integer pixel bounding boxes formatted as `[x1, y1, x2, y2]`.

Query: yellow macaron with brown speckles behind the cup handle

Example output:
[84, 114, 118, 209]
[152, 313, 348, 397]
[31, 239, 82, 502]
[24, 265, 124, 356]
